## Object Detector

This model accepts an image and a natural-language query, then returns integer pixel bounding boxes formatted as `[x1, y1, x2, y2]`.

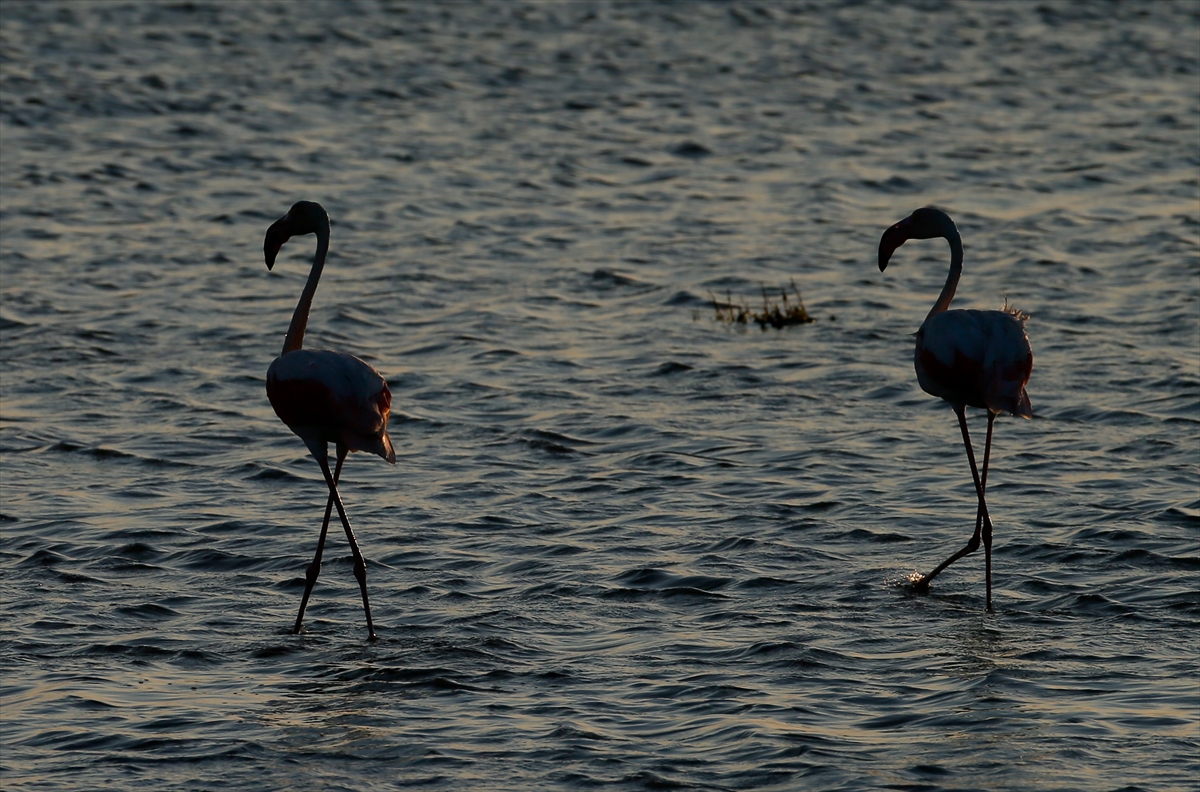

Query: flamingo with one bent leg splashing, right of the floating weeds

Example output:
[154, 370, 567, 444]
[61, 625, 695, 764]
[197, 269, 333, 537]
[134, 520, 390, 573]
[880, 206, 1033, 611]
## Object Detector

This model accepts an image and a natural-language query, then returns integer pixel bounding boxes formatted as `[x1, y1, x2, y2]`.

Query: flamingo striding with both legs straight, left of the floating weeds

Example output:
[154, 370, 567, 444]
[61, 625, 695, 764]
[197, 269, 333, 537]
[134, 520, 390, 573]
[263, 200, 396, 641]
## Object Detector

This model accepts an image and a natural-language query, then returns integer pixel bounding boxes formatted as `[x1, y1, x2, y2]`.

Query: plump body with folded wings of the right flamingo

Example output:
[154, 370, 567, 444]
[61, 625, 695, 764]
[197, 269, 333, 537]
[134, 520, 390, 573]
[914, 311, 1033, 418]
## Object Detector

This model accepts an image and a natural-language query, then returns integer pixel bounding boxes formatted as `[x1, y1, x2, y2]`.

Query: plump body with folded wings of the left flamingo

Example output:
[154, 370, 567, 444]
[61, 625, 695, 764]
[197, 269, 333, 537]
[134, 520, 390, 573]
[266, 349, 396, 464]
